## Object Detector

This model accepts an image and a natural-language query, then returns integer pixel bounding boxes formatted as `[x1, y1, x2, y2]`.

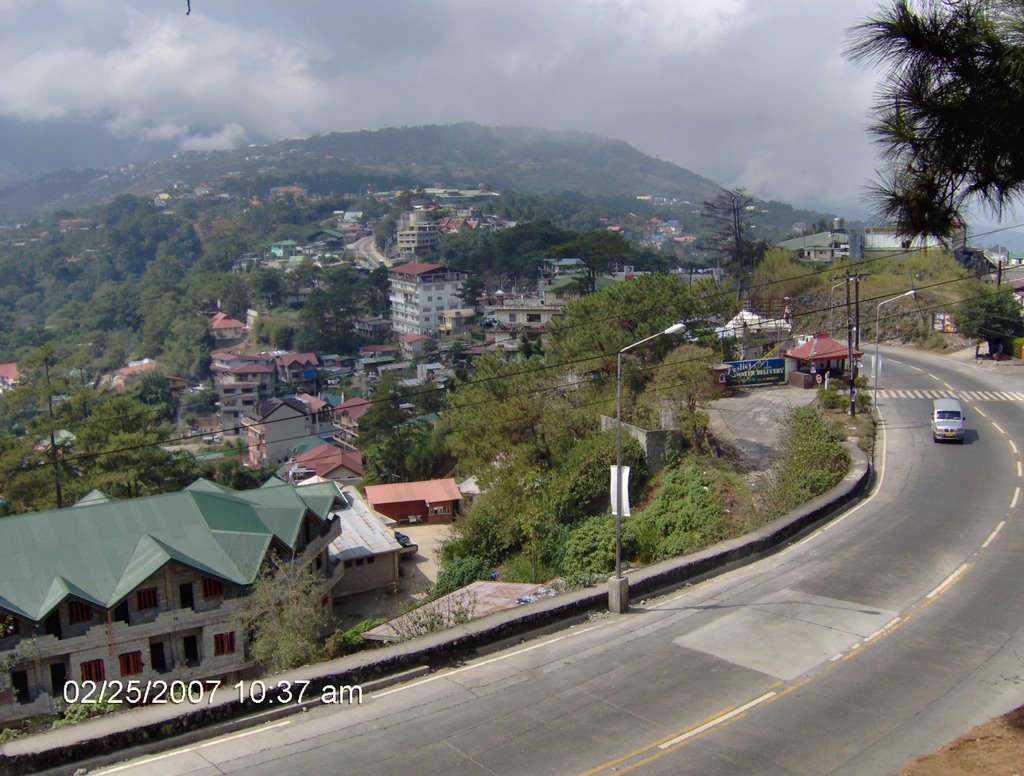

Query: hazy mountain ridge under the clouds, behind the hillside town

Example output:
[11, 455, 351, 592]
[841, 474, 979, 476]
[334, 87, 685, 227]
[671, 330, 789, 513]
[0, 123, 722, 223]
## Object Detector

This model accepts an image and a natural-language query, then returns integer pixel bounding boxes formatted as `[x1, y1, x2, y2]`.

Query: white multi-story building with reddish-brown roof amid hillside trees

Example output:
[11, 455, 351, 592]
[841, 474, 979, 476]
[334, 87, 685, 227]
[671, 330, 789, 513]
[388, 262, 469, 337]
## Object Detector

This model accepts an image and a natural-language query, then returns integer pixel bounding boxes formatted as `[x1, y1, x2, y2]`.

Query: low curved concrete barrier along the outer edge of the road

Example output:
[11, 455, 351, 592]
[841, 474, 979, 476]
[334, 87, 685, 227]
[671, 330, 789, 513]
[0, 442, 871, 776]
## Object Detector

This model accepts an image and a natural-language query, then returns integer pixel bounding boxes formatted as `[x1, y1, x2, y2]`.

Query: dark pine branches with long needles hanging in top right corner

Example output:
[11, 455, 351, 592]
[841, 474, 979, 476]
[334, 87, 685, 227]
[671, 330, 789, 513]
[847, 0, 1024, 236]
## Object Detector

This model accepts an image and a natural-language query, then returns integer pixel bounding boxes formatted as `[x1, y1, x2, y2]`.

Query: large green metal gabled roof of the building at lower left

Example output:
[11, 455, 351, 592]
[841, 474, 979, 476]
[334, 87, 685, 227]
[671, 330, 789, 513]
[0, 480, 334, 622]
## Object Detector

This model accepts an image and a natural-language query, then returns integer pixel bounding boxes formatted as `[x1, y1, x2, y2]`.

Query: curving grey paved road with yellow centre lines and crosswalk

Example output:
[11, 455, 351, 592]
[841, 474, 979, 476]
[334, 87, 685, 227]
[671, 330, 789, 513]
[96, 353, 1024, 775]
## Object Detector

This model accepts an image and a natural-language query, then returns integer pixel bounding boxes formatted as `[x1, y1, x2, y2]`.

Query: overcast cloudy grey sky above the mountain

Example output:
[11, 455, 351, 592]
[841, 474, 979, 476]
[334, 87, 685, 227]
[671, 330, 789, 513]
[0, 0, 897, 217]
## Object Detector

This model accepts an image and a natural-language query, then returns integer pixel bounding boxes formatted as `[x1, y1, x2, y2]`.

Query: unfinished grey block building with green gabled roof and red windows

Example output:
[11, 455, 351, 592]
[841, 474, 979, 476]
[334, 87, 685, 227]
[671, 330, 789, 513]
[0, 479, 344, 723]
